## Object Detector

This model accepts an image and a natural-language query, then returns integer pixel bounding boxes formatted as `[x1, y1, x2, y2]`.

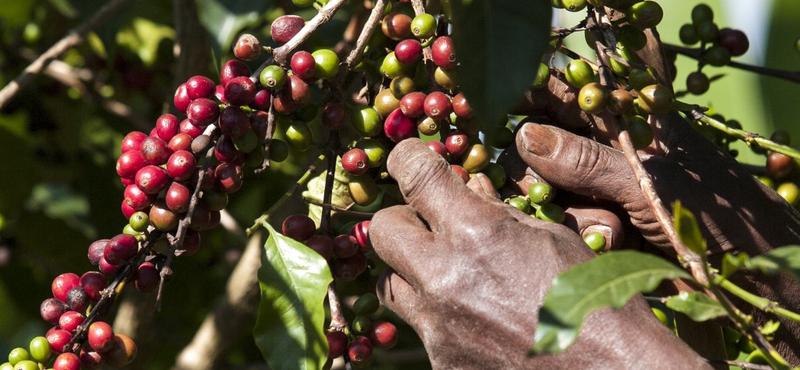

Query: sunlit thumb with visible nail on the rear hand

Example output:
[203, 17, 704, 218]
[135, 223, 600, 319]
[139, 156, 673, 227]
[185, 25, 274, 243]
[516, 123, 645, 207]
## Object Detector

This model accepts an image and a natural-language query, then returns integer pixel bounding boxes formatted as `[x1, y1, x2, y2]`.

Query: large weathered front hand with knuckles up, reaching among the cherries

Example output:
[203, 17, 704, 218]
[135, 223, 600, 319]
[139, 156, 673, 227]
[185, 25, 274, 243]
[370, 139, 708, 369]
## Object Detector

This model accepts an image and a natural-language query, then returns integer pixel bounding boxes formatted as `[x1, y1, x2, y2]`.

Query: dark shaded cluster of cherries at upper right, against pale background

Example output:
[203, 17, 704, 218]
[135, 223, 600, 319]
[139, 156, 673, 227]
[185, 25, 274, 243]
[679, 4, 750, 95]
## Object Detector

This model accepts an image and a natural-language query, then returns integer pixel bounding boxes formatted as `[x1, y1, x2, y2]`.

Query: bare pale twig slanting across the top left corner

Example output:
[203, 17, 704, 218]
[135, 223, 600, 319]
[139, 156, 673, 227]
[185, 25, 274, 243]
[0, 0, 131, 109]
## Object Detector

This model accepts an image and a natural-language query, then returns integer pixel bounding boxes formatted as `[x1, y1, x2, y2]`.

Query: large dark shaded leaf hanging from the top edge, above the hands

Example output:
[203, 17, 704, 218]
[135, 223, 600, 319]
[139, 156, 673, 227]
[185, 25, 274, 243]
[450, 0, 552, 133]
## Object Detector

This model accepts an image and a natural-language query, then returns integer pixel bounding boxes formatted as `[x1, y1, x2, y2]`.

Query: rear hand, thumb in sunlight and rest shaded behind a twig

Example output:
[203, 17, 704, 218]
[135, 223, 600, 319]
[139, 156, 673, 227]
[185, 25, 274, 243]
[510, 114, 800, 363]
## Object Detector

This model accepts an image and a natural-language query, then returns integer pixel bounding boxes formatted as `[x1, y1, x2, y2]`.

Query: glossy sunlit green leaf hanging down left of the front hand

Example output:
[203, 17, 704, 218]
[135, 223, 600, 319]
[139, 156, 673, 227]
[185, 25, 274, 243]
[253, 223, 333, 370]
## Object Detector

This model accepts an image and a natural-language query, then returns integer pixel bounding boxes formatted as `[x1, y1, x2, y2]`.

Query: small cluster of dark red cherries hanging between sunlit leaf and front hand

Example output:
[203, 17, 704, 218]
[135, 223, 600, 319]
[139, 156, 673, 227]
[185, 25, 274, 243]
[325, 293, 397, 368]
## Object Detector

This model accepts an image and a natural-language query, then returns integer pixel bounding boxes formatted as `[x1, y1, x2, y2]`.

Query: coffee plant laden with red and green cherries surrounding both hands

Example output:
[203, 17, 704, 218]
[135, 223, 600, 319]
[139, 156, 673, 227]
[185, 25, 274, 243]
[0, 0, 800, 370]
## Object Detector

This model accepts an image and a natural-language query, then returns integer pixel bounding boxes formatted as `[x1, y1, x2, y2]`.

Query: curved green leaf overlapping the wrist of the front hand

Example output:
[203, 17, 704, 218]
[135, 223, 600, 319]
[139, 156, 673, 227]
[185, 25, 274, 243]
[531, 251, 691, 353]
